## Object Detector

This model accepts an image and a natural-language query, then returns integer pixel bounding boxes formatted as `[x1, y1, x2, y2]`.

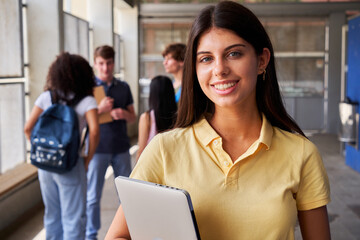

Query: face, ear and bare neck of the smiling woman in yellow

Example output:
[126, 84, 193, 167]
[196, 27, 270, 159]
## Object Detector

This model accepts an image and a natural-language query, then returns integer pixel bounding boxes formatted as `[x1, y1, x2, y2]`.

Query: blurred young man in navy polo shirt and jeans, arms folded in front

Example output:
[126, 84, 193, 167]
[86, 45, 136, 240]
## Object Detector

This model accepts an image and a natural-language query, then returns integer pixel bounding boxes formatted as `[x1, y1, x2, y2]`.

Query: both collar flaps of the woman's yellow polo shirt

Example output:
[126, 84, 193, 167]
[193, 114, 273, 150]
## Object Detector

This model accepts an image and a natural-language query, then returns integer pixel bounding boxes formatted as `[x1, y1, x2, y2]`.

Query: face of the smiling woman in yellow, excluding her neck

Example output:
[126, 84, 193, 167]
[196, 28, 270, 108]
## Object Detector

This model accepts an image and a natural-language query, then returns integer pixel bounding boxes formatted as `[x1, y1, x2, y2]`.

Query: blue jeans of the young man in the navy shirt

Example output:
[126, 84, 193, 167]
[86, 151, 131, 240]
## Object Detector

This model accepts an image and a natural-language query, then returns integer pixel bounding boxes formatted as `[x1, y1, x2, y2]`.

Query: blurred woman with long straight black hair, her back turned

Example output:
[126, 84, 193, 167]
[136, 76, 177, 159]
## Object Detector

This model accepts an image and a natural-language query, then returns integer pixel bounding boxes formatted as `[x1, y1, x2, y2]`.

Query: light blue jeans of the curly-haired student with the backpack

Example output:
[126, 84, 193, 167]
[38, 158, 86, 240]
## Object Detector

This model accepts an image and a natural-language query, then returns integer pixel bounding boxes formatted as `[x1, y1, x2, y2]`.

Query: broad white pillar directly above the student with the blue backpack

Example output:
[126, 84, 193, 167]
[27, 0, 63, 108]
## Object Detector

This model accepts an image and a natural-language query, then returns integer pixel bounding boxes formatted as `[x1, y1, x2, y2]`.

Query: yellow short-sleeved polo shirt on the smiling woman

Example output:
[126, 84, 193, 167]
[131, 116, 330, 240]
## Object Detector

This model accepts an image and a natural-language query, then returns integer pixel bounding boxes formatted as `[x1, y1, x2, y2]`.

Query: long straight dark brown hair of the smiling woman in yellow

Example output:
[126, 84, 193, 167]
[175, 1, 304, 135]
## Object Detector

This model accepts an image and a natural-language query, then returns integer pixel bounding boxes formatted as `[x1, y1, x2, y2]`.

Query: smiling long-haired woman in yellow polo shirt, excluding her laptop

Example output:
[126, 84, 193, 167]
[106, 1, 330, 239]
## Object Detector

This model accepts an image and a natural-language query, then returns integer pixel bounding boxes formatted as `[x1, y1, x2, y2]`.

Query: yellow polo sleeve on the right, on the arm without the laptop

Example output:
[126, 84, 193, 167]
[296, 141, 330, 211]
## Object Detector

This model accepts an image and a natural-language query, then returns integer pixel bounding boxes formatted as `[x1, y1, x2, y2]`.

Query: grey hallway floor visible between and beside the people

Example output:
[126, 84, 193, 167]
[4, 134, 360, 240]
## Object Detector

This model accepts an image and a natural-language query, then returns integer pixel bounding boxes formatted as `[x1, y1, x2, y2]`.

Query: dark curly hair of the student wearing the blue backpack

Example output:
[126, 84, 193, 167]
[44, 52, 95, 104]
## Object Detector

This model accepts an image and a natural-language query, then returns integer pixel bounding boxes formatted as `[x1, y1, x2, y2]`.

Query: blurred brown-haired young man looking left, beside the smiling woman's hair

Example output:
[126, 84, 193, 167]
[162, 43, 186, 102]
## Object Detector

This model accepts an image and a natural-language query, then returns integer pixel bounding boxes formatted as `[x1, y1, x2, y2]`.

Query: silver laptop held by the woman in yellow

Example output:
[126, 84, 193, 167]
[115, 176, 200, 240]
